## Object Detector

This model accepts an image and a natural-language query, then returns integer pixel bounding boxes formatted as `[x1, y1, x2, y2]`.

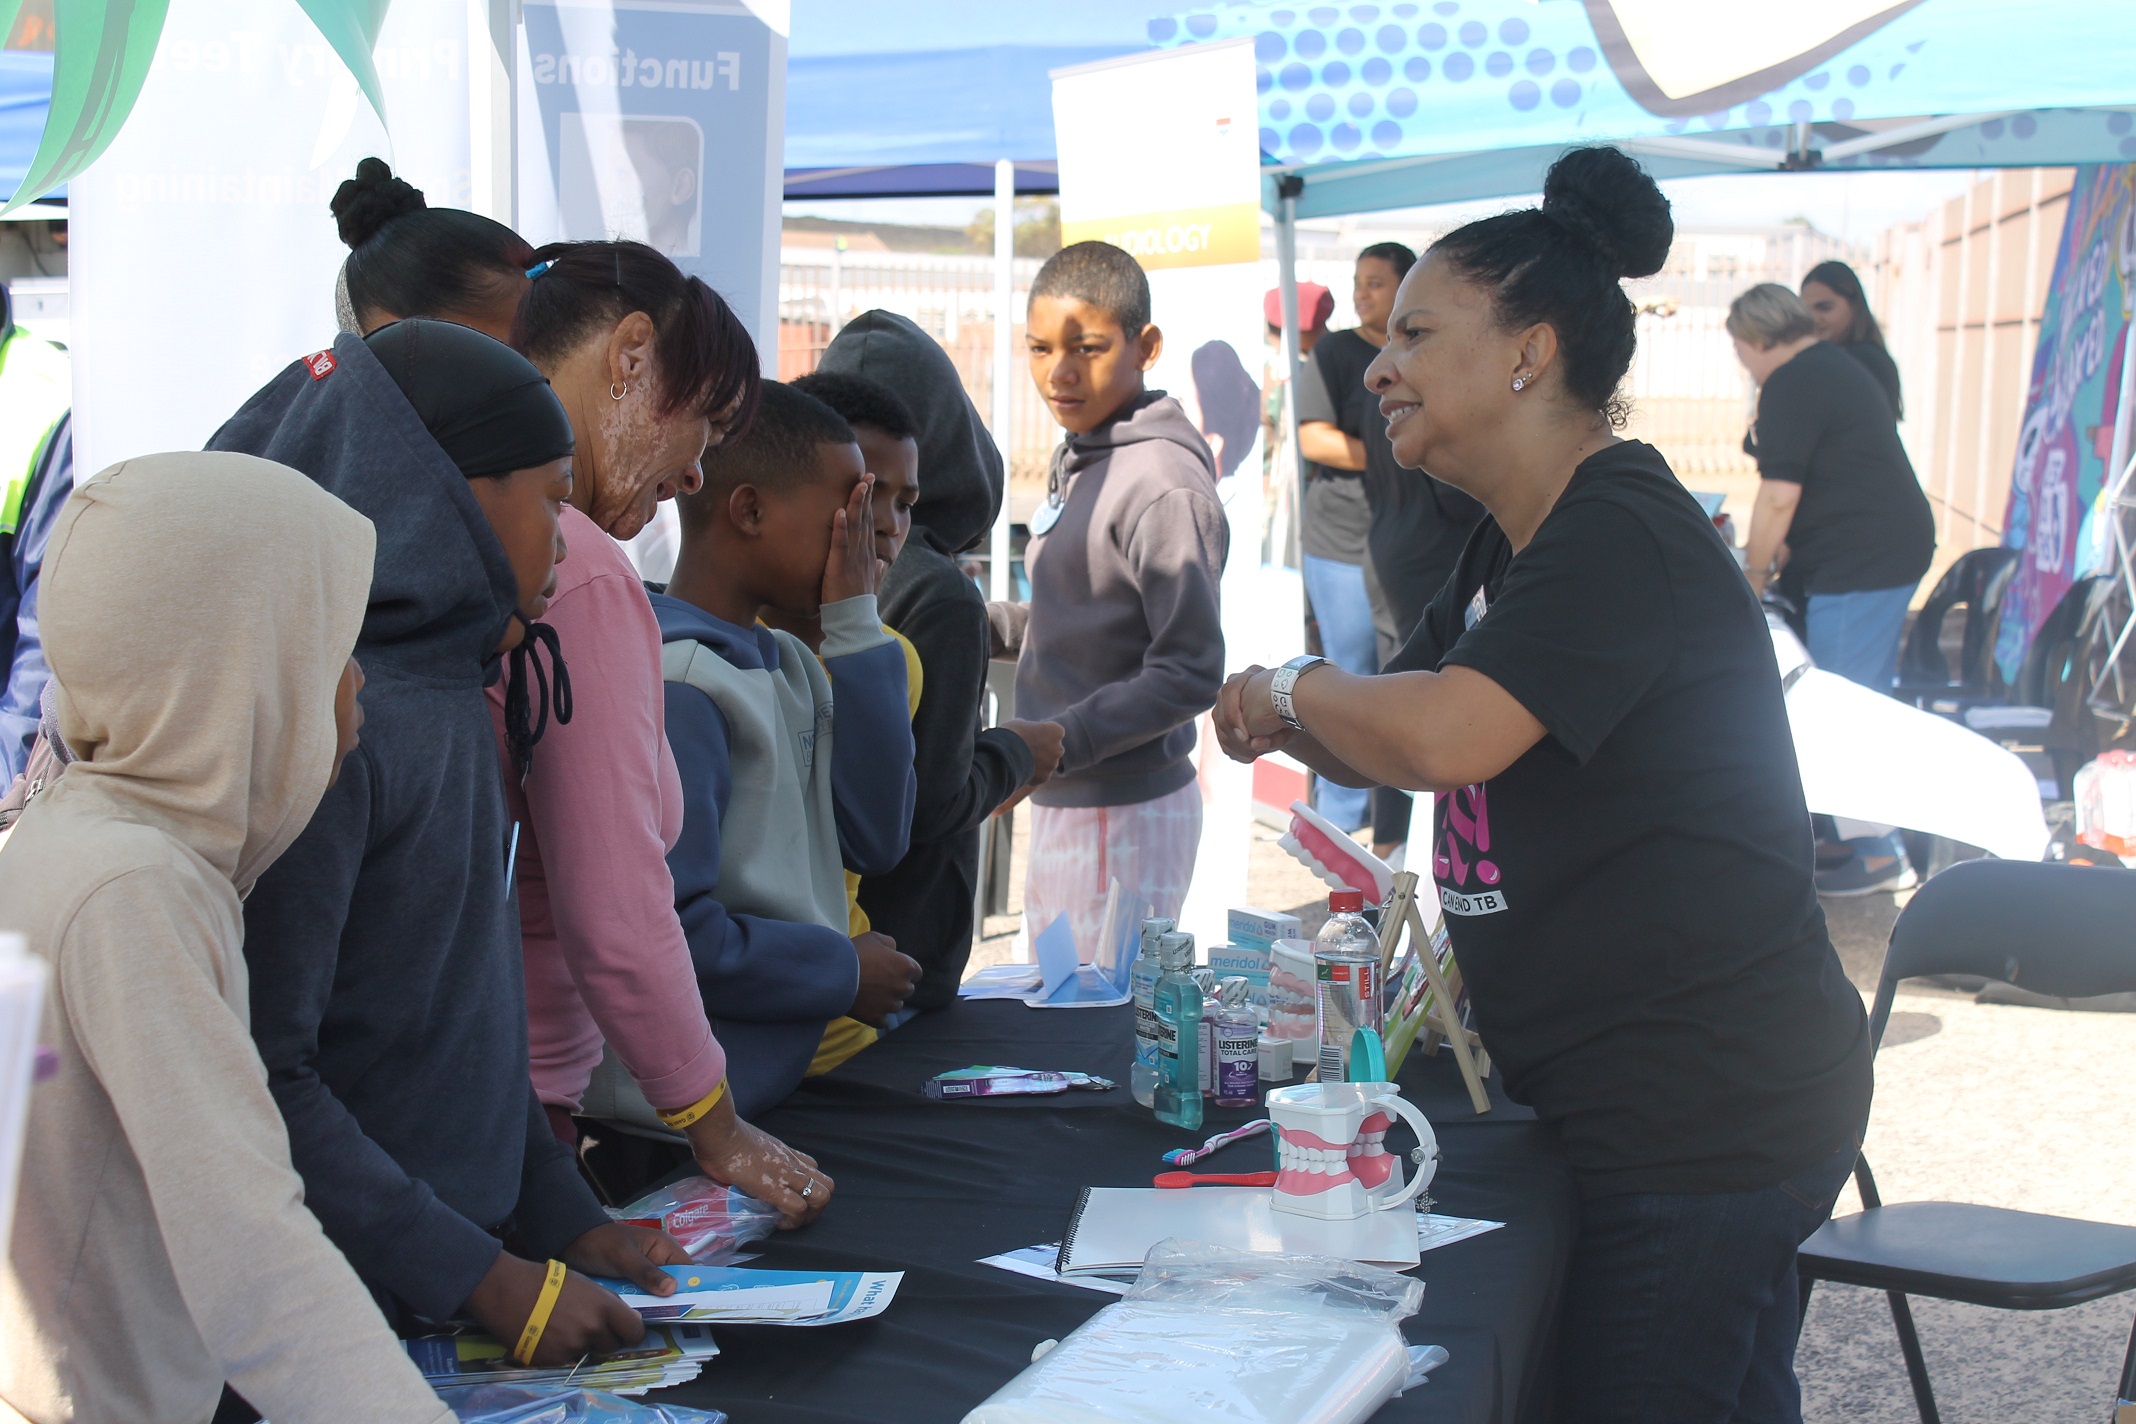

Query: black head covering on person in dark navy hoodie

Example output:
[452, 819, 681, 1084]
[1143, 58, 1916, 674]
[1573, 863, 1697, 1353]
[363, 318, 572, 480]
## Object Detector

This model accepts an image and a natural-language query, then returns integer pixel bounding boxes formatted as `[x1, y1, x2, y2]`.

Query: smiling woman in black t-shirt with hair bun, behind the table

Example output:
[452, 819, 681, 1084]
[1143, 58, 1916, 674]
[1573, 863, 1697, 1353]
[1215, 147, 1869, 1424]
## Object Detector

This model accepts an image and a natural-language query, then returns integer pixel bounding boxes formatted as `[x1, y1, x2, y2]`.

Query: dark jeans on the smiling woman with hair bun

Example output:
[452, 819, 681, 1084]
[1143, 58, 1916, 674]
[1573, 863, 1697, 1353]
[1557, 1146, 1856, 1424]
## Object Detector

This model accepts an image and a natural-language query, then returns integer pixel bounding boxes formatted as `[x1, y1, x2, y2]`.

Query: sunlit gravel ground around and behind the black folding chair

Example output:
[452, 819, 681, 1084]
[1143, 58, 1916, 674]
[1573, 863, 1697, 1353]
[972, 813, 2136, 1424]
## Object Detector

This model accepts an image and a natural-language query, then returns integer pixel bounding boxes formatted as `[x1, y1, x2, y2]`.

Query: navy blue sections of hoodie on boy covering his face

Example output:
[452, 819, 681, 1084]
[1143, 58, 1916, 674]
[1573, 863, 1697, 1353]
[654, 594, 912, 1117]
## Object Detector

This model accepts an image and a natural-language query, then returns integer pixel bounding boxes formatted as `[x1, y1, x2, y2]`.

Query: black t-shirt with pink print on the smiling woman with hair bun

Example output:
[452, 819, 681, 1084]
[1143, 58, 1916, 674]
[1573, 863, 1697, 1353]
[1386, 442, 1869, 1196]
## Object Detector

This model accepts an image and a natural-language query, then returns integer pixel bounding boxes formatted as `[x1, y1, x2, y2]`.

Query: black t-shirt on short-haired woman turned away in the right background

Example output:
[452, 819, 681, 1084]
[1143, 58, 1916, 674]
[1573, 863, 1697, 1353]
[1749, 342, 1935, 594]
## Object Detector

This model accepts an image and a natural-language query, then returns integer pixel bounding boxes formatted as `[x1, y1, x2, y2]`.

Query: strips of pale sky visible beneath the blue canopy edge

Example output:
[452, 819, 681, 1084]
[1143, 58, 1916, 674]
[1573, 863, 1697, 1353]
[786, 169, 1986, 241]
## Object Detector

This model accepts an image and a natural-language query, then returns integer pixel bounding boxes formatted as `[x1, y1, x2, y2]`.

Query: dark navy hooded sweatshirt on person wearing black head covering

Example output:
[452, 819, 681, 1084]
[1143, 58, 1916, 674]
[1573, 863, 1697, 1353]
[211, 335, 607, 1319]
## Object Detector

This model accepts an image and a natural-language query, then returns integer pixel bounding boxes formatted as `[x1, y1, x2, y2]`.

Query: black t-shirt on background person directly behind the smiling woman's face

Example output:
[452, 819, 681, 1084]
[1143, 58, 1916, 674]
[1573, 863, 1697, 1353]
[1299, 331, 1482, 638]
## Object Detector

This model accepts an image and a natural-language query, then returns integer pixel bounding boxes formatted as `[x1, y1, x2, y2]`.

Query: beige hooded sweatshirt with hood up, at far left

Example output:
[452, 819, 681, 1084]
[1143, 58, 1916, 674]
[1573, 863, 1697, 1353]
[0, 455, 453, 1424]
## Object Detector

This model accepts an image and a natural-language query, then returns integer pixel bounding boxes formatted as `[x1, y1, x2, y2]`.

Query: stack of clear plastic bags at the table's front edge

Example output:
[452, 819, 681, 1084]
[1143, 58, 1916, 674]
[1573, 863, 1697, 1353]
[963, 1240, 1425, 1424]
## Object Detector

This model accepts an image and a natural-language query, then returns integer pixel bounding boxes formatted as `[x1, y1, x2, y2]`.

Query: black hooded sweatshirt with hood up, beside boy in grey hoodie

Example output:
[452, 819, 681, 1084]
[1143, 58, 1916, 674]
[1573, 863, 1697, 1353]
[820, 312, 1032, 1010]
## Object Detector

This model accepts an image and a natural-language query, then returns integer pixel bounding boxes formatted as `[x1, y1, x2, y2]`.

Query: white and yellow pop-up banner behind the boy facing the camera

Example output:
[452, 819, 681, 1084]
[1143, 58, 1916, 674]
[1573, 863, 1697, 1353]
[1053, 38, 1305, 944]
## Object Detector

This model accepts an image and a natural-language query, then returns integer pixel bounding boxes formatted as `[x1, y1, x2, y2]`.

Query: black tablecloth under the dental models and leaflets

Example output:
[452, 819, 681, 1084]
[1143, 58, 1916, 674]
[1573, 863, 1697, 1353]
[656, 1001, 1574, 1424]
